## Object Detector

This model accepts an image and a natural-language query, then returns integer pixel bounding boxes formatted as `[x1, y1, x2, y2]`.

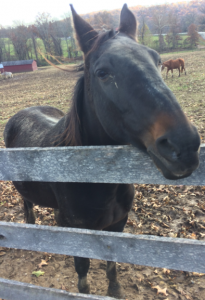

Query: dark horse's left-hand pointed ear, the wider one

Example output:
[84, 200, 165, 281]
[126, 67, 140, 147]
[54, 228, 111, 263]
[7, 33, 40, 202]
[70, 4, 98, 54]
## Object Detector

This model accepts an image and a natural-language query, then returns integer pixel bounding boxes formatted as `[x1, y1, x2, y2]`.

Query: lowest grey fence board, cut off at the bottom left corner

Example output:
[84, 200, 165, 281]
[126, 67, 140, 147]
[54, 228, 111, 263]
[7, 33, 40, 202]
[0, 278, 114, 300]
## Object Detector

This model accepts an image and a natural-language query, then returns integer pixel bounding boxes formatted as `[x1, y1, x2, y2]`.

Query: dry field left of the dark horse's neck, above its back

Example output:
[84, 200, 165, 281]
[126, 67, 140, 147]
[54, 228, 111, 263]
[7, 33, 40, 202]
[0, 67, 79, 146]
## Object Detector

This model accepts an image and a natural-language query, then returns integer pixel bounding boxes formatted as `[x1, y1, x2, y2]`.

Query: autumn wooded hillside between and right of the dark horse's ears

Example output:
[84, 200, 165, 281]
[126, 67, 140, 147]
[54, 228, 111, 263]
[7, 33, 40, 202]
[85, 0, 205, 52]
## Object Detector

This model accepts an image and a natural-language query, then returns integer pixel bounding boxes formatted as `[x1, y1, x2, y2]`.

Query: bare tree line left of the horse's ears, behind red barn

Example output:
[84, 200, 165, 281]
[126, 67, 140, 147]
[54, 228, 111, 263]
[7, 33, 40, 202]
[0, 13, 78, 65]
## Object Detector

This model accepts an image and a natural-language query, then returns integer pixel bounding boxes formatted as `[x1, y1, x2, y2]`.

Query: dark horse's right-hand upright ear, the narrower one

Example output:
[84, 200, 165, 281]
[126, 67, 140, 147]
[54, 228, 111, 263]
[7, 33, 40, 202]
[119, 4, 137, 38]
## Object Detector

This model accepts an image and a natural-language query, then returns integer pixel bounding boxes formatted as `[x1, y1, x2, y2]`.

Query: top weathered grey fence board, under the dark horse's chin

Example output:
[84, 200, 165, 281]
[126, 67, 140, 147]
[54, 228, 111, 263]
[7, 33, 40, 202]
[0, 145, 205, 185]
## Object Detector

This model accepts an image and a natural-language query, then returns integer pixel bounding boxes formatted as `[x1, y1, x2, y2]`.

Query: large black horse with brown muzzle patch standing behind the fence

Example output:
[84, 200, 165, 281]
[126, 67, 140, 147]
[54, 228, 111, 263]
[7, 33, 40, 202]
[4, 4, 200, 298]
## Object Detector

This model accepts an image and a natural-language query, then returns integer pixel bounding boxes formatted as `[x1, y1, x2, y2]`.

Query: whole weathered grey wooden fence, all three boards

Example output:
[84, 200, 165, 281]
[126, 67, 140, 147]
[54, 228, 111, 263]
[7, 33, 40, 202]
[0, 145, 205, 300]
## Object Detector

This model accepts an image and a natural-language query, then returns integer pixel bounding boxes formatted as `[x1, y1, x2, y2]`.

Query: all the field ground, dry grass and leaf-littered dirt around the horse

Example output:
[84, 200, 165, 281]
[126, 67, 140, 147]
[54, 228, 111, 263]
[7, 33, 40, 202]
[0, 51, 205, 300]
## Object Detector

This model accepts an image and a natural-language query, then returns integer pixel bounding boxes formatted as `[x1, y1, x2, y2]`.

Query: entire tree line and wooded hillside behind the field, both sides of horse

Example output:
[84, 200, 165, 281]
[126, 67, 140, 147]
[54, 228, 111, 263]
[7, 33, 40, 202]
[0, 0, 205, 65]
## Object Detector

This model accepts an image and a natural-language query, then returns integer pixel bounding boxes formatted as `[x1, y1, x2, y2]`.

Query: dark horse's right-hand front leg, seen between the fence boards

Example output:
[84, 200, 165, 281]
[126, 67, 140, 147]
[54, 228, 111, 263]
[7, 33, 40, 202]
[104, 217, 128, 299]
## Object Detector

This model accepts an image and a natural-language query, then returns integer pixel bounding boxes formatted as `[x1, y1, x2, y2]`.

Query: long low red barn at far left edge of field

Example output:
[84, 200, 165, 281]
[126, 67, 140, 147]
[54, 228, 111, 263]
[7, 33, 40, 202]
[2, 59, 38, 73]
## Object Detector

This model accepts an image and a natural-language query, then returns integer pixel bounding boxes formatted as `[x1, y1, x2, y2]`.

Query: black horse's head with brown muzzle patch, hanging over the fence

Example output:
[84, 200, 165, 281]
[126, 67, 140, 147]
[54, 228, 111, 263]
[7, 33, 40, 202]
[71, 4, 200, 179]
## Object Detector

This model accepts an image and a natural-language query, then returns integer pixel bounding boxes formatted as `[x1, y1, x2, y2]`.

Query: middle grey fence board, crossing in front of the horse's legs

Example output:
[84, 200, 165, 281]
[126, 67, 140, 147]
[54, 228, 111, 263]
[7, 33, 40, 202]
[0, 222, 205, 273]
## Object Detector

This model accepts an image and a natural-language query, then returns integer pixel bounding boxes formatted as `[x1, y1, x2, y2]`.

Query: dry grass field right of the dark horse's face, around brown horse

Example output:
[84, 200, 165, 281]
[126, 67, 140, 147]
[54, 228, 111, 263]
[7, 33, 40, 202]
[162, 50, 205, 142]
